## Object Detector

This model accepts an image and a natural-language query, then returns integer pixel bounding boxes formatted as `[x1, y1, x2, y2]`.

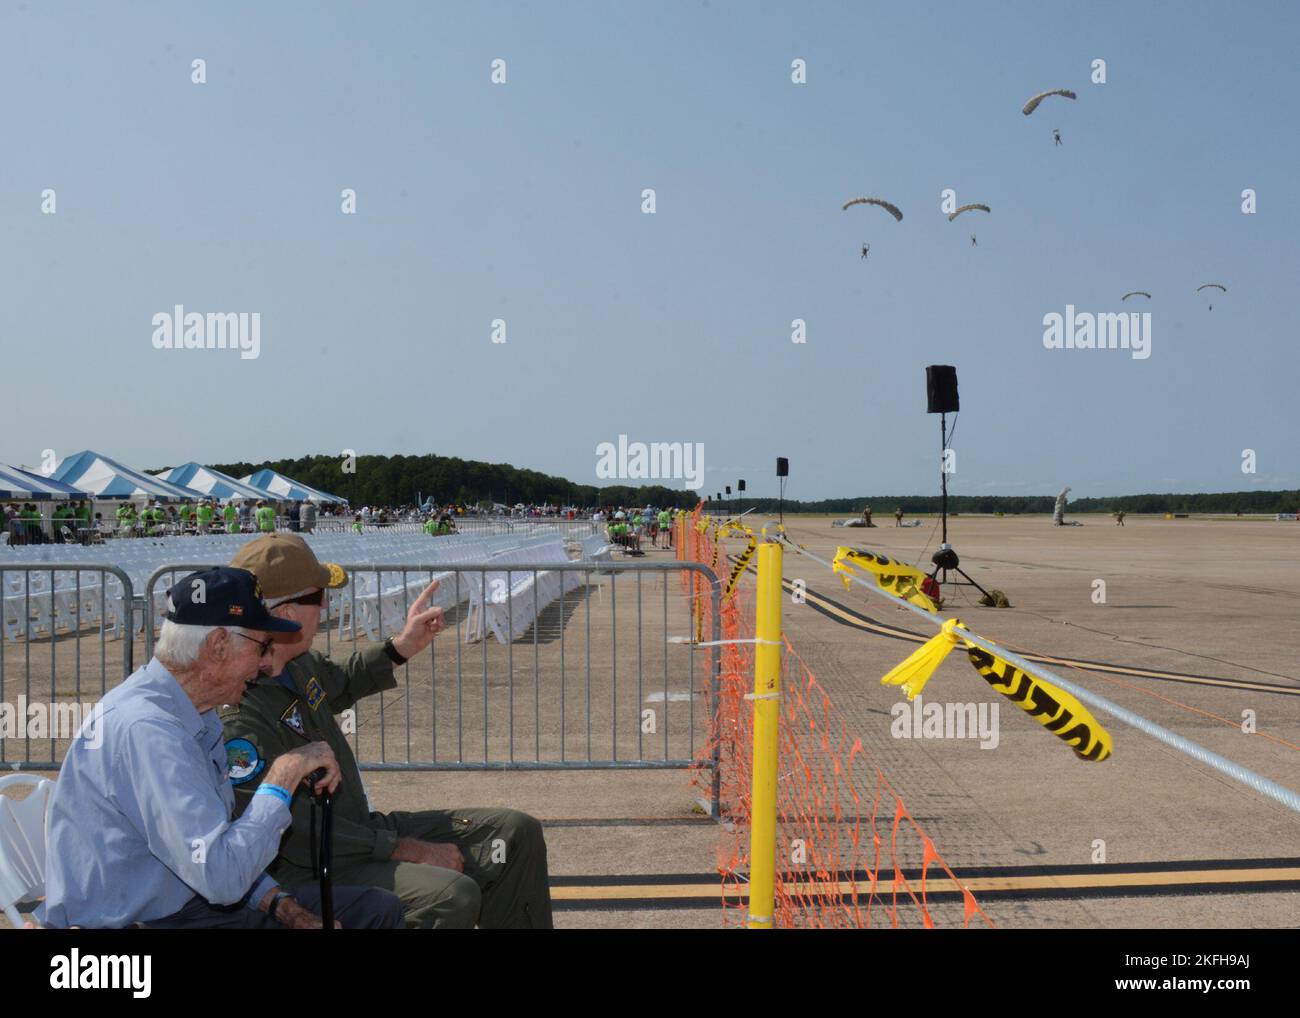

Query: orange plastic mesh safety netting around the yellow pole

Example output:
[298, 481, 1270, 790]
[679, 508, 993, 928]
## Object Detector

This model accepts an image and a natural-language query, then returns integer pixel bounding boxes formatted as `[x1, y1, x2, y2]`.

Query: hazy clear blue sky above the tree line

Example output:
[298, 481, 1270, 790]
[0, 0, 1300, 498]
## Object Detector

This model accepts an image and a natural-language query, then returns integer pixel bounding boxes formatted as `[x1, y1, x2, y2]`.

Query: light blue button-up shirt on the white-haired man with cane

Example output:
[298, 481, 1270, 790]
[43, 658, 293, 927]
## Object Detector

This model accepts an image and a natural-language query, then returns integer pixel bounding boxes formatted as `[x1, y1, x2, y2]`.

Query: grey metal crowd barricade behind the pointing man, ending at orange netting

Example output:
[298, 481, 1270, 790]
[143, 560, 722, 816]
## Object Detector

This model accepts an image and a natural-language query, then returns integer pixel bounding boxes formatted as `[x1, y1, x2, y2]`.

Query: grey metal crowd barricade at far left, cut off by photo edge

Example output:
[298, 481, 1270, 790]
[0, 562, 135, 771]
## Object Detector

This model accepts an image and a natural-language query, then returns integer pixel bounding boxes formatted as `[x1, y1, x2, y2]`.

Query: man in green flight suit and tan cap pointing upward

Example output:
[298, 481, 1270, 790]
[221, 533, 551, 930]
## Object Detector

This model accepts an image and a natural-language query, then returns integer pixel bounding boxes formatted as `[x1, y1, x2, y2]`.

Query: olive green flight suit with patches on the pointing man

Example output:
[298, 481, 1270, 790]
[221, 645, 551, 928]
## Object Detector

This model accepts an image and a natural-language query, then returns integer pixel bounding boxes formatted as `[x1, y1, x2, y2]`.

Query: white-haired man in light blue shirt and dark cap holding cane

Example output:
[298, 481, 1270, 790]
[43, 568, 402, 930]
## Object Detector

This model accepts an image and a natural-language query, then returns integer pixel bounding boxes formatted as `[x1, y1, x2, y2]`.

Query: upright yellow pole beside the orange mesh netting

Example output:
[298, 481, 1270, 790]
[749, 543, 781, 930]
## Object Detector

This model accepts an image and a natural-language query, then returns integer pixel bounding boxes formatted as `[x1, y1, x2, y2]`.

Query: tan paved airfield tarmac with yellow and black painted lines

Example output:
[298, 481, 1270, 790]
[7, 516, 1300, 928]
